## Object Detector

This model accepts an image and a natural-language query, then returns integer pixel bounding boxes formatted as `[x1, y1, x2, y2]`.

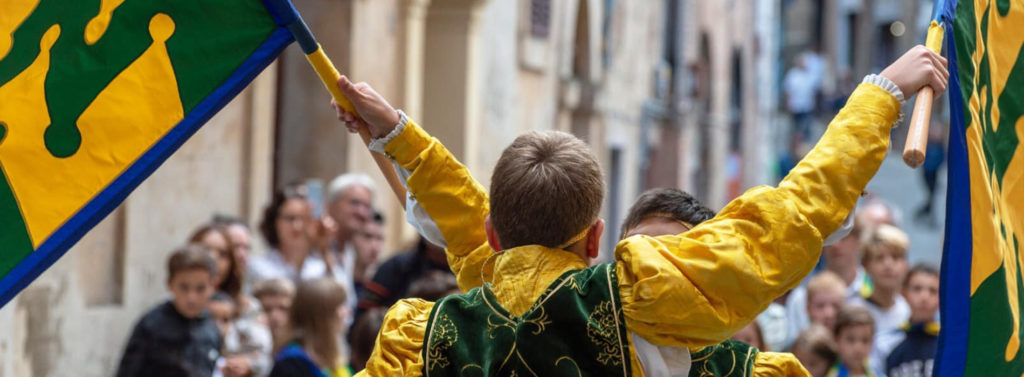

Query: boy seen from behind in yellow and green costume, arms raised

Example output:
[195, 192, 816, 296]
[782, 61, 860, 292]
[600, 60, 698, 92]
[339, 48, 946, 376]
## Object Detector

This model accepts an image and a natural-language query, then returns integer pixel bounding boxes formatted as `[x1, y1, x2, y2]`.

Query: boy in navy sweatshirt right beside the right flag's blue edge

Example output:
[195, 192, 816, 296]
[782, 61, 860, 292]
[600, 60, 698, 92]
[886, 264, 939, 377]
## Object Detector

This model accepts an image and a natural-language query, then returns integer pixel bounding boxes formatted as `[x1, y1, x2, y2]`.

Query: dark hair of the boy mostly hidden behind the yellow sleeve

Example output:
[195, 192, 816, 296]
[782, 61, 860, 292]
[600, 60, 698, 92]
[621, 187, 715, 236]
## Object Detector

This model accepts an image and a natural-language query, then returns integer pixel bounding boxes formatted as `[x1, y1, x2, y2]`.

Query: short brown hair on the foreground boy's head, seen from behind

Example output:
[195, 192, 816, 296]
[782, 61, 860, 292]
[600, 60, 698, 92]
[490, 131, 604, 249]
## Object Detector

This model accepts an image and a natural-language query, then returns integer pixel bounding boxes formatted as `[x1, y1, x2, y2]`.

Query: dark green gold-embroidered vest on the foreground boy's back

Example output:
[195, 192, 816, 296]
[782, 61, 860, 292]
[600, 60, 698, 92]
[423, 264, 631, 377]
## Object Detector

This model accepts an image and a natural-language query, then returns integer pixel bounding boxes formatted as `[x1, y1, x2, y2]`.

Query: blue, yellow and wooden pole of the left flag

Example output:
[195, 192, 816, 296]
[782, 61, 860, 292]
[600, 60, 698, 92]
[263, 0, 406, 207]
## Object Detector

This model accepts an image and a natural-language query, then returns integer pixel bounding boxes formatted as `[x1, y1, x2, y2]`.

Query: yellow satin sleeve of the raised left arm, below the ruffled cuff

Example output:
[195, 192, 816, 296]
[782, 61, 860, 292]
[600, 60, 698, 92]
[384, 121, 494, 292]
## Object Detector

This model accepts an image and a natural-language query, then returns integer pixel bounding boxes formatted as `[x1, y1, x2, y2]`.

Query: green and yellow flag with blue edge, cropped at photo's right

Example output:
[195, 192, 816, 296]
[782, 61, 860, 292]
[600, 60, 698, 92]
[936, 0, 1024, 376]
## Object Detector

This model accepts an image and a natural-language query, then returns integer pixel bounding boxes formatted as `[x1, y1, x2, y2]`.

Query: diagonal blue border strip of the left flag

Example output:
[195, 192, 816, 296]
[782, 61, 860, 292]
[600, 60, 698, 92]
[0, 11, 295, 307]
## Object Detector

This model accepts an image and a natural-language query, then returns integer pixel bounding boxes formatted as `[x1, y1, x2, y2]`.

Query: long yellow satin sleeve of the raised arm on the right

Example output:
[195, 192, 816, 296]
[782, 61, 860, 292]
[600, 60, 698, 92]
[615, 84, 899, 347]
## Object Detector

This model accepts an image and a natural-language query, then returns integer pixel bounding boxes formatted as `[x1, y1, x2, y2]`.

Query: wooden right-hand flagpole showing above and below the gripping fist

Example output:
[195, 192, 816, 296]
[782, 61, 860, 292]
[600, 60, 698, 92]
[903, 20, 943, 168]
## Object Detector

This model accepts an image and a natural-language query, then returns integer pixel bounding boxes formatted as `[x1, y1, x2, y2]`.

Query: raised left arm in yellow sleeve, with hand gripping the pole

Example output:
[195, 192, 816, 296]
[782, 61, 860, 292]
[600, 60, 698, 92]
[338, 76, 493, 291]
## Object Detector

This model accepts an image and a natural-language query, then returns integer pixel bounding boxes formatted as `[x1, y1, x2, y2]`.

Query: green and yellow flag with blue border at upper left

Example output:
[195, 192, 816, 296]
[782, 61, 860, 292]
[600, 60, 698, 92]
[0, 0, 301, 306]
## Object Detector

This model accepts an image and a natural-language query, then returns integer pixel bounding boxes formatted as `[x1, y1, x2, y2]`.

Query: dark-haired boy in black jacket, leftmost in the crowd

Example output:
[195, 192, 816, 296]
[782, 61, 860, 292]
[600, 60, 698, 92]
[117, 245, 222, 377]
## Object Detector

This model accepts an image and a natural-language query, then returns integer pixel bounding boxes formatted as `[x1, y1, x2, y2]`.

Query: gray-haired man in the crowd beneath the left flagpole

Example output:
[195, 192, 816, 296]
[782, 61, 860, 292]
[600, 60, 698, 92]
[325, 173, 377, 310]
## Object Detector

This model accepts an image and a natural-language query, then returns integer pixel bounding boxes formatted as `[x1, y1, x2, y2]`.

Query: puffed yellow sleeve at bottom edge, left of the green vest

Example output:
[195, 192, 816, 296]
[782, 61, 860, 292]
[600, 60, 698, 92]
[355, 298, 434, 377]
